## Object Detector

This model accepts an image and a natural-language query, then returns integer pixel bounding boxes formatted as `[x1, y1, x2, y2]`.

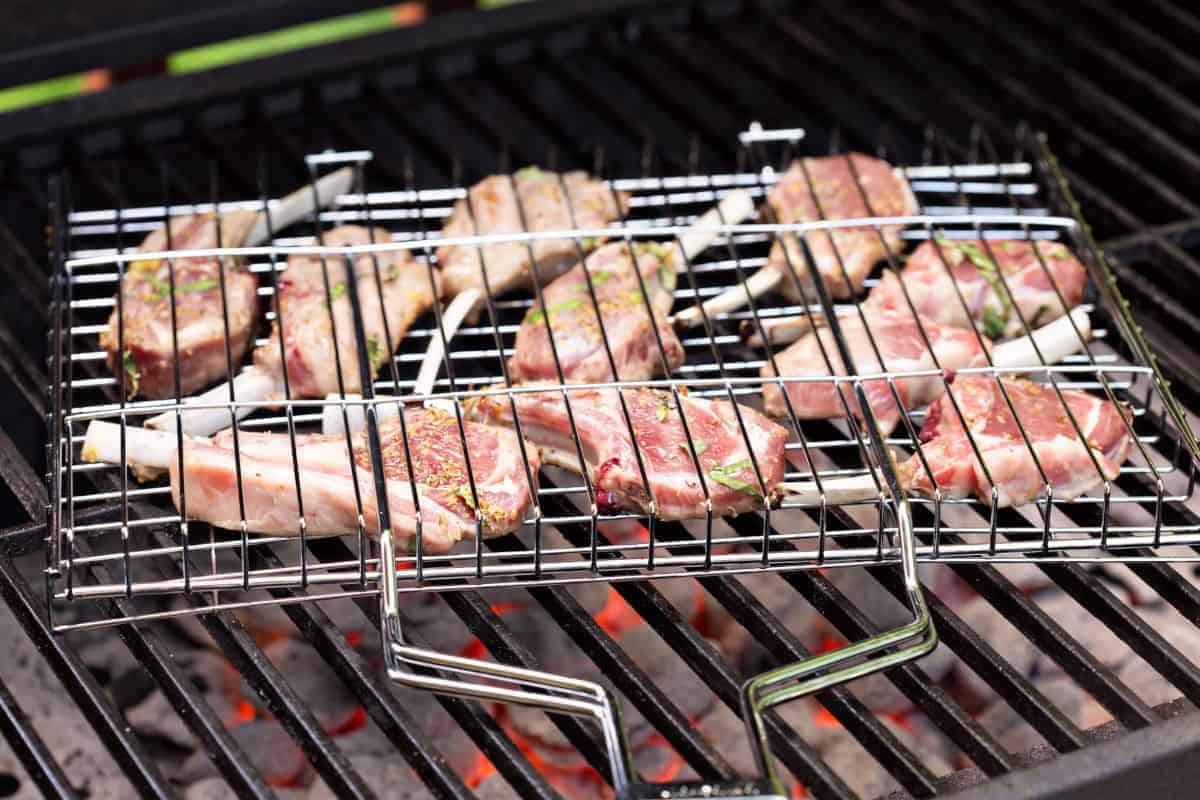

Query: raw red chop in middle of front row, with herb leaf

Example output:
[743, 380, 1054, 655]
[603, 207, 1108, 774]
[467, 385, 787, 519]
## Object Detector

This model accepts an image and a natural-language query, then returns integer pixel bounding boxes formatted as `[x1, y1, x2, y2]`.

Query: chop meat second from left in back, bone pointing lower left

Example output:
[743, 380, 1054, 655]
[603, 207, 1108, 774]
[254, 225, 437, 399]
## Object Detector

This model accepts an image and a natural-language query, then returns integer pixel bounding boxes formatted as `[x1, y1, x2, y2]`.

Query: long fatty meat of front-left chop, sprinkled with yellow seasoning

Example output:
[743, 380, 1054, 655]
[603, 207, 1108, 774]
[163, 408, 540, 553]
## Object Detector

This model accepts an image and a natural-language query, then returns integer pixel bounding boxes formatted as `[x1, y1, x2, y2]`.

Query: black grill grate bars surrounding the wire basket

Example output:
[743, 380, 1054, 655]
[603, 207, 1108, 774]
[0, 0, 1200, 798]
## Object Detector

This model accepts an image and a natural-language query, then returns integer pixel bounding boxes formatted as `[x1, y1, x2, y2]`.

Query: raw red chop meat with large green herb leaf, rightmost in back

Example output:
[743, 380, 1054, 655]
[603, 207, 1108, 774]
[869, 237, 1087, 339]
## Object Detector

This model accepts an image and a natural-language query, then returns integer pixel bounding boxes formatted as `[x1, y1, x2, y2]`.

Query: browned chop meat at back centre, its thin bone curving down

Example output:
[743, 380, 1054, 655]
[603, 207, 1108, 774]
[437, 167, 629, 296]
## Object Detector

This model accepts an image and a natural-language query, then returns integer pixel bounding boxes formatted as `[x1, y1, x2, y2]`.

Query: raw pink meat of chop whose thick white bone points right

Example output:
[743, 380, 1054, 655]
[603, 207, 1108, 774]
[761, 309, 985, 435]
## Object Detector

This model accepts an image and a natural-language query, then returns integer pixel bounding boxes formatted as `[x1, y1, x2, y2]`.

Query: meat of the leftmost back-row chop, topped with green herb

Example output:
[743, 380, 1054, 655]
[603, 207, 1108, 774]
[100, 211, 258, 399]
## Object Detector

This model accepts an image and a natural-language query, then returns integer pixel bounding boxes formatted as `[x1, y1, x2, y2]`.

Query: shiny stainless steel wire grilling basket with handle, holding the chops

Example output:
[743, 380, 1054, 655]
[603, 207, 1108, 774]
[47, 126, 1200, 796]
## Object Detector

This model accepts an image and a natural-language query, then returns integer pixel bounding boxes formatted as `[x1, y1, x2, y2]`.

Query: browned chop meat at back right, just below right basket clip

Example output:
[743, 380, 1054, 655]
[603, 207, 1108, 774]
[767, 152, 918, 302]
